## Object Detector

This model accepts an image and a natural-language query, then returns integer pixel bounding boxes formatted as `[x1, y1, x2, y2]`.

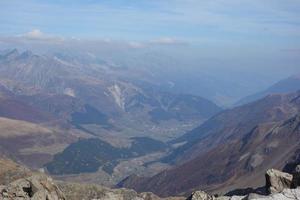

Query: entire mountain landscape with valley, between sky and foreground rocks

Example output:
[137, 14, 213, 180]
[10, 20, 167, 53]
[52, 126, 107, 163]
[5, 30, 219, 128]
[0, 49, 300, 197]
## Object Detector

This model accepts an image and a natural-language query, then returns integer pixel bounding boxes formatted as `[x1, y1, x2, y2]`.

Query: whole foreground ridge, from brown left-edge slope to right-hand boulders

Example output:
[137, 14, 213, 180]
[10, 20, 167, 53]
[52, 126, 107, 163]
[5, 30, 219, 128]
[0, 158, 300, 200]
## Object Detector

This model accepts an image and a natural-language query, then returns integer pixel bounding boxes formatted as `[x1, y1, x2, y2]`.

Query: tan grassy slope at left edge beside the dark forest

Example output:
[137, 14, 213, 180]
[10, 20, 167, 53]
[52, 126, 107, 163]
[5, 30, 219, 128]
[0, 117, 84, 168]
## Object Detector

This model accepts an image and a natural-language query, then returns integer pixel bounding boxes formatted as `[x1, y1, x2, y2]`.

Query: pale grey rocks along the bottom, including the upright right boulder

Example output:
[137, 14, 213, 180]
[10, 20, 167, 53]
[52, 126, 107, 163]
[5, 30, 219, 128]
[0, 174, 300, 200]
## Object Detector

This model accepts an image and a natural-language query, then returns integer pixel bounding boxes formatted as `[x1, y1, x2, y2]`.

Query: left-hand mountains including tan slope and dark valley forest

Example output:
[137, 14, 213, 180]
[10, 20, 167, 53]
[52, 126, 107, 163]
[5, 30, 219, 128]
[0, 49, 222, 185]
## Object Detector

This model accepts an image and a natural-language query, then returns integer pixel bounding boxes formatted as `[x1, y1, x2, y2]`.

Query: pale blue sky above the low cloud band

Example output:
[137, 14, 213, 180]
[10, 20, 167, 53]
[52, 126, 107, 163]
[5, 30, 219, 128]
[0, 0, 300, 44]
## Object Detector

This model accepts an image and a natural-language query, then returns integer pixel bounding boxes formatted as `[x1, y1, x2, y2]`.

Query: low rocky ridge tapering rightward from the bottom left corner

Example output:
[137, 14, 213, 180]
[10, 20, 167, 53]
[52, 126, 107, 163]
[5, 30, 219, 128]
[0, 173, 185, 200]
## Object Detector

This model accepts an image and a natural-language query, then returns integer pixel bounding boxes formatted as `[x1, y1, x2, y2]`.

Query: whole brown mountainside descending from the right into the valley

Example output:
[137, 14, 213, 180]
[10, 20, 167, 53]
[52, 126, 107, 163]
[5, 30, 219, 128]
[120, 93, 300, 196]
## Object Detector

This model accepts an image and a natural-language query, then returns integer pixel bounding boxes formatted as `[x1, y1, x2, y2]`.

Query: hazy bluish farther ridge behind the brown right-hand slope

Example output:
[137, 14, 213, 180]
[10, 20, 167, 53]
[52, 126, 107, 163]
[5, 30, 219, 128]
[166, 92, 300, 163]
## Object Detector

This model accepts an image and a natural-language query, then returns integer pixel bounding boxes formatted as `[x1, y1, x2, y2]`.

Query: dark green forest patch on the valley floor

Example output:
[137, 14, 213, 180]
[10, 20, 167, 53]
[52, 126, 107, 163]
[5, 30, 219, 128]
[46, 138, 167, 174]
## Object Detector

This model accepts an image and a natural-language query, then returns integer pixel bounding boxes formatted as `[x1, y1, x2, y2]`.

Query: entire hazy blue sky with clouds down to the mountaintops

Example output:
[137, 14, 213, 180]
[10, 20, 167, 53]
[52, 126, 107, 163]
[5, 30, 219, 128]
[0, 0, 300, 76]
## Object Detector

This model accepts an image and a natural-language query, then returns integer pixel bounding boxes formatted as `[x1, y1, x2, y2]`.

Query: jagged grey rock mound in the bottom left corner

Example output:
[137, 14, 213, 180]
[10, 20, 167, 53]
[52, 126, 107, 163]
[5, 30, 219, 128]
[0, 174, 65, 200]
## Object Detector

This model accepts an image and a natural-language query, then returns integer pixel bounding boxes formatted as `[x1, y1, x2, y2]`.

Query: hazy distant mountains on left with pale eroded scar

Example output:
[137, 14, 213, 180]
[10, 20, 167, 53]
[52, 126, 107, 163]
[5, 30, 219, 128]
[0, 50, 221, 140]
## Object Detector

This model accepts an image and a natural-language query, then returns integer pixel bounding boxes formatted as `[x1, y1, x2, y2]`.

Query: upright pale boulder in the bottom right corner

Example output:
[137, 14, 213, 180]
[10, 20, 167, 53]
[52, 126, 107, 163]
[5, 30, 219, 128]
[266, 169, 293, 194]
